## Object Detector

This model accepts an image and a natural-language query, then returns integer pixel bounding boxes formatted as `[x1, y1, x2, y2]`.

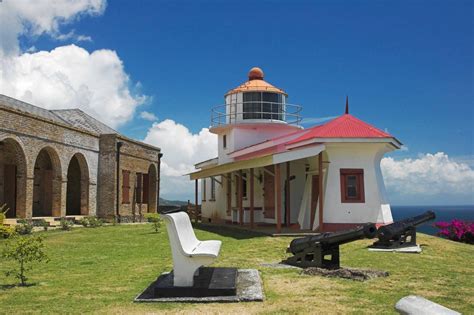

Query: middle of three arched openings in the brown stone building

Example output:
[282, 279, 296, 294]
[33, 147, 62, 217]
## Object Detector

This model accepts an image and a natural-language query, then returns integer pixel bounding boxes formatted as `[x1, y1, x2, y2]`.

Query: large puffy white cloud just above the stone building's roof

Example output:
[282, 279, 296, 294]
[0, 45, 146, 127]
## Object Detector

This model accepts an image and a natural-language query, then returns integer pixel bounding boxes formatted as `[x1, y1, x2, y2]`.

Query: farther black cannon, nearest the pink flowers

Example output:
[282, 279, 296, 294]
[369, 211, 436, 249]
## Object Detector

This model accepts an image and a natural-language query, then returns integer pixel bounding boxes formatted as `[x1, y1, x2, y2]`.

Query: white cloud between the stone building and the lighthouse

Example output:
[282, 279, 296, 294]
[144, 119, 217, 199]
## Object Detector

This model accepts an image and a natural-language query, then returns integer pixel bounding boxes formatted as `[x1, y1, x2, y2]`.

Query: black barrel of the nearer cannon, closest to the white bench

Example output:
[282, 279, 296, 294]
[289, 223, 377, 255]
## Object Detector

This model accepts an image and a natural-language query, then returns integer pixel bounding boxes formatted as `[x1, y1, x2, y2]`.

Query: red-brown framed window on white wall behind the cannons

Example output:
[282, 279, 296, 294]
[341, 168, 365, 203]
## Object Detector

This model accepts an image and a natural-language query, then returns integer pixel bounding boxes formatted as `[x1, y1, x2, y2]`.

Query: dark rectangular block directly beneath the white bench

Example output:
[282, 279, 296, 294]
[155, 267, 237, 298]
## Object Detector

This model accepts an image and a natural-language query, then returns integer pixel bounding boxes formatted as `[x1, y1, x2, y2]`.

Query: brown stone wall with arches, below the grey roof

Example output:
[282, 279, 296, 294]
[0, 104, 160, 218]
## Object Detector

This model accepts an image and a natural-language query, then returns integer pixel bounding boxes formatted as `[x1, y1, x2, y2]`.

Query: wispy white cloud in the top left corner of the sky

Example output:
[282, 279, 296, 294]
[0, 0, 106, 55]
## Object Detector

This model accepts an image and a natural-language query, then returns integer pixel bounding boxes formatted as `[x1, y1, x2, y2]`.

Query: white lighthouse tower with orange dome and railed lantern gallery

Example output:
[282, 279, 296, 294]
[210, 67, 301, 164]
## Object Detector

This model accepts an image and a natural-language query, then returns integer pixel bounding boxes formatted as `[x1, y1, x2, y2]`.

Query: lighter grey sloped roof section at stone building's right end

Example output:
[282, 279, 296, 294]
[52, 108, 118, 134]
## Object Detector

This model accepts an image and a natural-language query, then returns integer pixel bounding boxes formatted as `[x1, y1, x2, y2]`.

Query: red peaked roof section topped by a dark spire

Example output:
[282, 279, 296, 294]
[286, 114, 393, 144]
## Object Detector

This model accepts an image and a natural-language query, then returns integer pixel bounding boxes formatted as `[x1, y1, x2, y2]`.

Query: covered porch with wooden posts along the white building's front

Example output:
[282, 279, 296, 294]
[190, 144, 327, 236]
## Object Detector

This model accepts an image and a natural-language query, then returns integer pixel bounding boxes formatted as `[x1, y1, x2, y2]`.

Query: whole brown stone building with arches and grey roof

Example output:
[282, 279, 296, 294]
[0, 94, 162, 221]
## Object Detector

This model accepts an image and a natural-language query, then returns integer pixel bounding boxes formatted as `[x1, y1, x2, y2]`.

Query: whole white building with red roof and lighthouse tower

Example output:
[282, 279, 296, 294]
[190, 68, 401, 232]
